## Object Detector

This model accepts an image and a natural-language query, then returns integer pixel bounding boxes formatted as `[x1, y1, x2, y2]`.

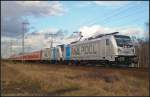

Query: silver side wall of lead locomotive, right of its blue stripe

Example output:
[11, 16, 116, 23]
[71, 36, 116, 61]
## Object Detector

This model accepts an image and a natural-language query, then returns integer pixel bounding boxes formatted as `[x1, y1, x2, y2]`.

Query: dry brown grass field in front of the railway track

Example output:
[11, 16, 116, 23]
[1, 62, 149, 96]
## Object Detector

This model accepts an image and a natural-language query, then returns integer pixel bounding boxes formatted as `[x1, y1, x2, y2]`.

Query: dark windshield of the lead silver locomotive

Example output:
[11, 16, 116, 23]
[114, 35, 133, 47]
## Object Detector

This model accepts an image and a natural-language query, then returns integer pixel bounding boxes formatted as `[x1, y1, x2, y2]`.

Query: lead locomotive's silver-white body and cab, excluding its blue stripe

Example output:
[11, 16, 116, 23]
[70, 35, 135, 65]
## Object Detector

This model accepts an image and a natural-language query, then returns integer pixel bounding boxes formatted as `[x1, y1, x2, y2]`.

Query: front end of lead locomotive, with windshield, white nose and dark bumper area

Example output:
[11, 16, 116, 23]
[114, 35, 137, 65]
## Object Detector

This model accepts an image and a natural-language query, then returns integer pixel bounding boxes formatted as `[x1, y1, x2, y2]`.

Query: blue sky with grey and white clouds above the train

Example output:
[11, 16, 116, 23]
[1, 1, 149, 57]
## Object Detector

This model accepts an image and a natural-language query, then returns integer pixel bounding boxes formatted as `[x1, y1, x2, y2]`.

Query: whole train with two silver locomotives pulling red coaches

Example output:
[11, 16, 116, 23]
[10, 32, 137, 66]
